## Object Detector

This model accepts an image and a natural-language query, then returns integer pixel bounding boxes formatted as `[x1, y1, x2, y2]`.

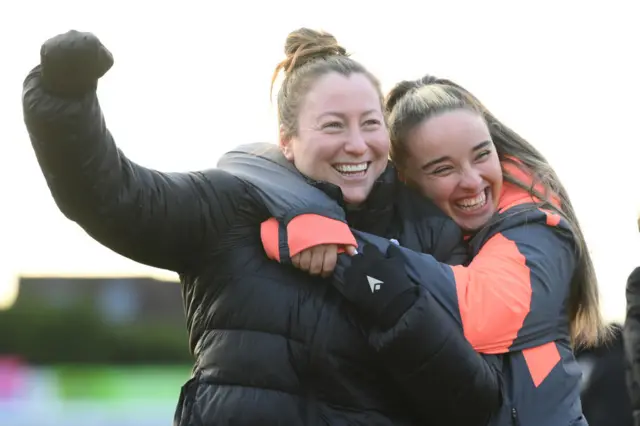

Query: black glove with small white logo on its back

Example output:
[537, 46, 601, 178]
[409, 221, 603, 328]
[333, 244, 420, 329]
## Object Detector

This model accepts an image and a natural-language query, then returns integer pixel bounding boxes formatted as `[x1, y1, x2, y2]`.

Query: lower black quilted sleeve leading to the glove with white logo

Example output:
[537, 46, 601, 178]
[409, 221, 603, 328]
[332, 230, 502, 425]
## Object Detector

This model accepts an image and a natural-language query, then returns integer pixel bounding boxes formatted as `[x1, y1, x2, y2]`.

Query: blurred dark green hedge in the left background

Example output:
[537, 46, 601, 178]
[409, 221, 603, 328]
[0, 280, 193, 365]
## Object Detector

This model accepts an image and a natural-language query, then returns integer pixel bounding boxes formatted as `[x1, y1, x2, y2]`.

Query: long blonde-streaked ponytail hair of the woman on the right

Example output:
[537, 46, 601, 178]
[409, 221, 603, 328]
[385, 76, 610, 346]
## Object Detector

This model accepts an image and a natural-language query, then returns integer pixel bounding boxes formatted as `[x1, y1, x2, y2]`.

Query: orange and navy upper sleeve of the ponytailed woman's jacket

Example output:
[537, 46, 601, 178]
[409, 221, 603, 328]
[452, 224, 576, 354]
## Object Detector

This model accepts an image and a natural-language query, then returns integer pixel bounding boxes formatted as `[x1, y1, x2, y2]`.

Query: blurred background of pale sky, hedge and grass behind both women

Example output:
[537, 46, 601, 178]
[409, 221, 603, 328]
[0, 0, 640, 426]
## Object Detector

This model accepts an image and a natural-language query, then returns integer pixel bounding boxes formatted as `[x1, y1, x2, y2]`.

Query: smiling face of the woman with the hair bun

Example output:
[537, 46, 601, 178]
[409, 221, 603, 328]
[280, 72, 389, 204]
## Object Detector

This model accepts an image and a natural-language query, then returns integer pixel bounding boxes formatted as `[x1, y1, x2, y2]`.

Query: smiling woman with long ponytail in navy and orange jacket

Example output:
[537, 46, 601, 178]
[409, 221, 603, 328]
[266, 71, 608, 426]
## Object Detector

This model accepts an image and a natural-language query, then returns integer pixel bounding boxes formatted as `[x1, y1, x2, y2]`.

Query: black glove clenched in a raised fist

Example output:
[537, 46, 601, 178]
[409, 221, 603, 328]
[40, 30, 113, 97]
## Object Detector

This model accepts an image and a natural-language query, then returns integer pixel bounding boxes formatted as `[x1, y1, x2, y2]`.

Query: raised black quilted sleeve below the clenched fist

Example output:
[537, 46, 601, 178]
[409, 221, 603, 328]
[23, 66, 246, 272]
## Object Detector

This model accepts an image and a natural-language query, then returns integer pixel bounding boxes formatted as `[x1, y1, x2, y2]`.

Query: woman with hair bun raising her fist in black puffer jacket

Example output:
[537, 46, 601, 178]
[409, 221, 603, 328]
[23, 28, 500, 426]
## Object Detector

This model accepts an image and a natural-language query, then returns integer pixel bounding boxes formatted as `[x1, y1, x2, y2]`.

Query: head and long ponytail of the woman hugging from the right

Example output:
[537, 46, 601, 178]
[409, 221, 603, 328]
[386, 75, 606, 344]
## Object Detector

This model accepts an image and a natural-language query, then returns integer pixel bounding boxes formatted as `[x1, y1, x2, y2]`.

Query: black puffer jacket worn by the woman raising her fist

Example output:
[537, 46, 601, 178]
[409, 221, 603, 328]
[23, 64, 499, 426]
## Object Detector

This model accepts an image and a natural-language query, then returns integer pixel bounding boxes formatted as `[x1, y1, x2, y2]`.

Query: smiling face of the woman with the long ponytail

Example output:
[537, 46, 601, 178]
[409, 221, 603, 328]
[403, 109, 503, 231]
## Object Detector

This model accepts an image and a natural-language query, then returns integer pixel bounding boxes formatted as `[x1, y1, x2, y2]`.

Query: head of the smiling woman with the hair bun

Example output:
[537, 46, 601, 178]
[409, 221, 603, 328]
[272, 29, 389, 204]
